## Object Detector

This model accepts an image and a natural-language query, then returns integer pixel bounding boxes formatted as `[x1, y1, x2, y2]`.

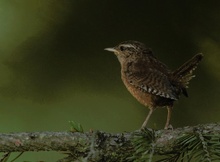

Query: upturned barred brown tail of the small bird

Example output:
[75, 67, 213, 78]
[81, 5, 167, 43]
[173, 53, 203, 96]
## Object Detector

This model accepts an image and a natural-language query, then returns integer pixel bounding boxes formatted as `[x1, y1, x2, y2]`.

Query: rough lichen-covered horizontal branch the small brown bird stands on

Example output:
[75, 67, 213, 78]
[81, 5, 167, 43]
[0, 123, 220, 161]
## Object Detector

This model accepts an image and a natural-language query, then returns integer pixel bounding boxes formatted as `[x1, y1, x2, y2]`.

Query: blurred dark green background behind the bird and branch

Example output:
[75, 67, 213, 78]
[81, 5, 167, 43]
[0, 0, 220, 161]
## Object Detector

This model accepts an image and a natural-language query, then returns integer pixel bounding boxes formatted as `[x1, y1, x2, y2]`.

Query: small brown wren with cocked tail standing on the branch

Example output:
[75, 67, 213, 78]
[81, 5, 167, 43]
[104, 40, 203, 129]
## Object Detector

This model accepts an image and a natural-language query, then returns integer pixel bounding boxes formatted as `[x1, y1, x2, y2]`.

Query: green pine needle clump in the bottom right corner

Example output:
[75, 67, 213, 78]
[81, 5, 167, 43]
[161, 130, 220, 162]
